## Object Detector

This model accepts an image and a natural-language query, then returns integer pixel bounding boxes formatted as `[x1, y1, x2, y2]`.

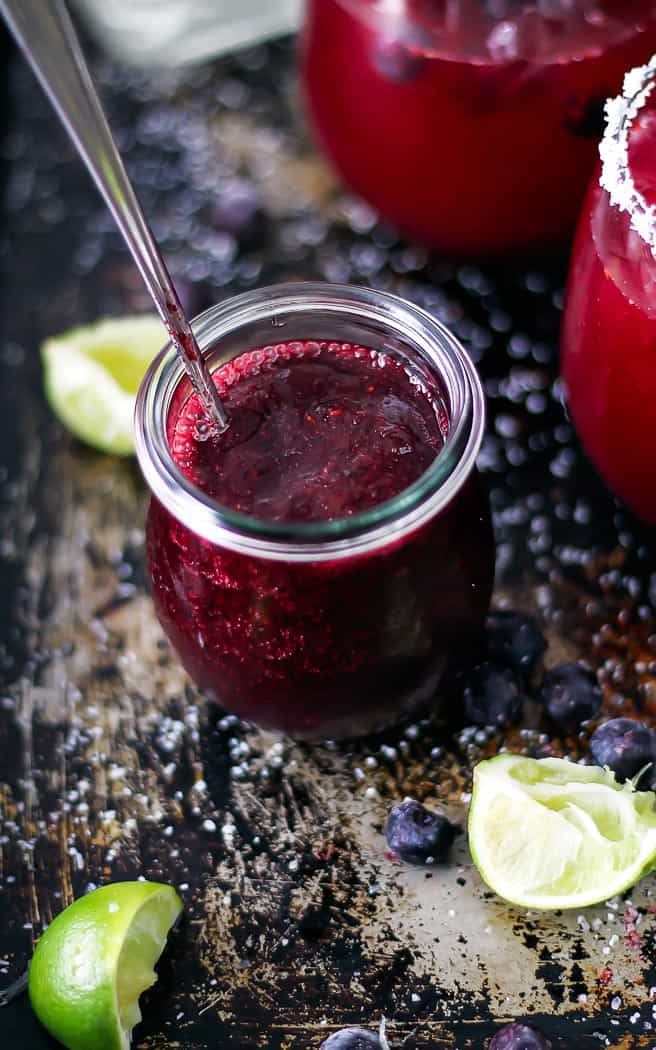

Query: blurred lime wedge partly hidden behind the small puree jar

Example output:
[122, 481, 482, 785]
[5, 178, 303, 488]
[41, 315, 167, 456]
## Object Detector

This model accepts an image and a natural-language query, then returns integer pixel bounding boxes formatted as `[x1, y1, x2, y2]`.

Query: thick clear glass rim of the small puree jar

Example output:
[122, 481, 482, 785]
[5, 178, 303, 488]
[134, 281, 485, 561]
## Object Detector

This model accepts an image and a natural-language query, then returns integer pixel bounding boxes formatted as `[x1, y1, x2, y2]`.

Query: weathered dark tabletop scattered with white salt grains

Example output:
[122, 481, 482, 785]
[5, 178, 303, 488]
[0, 34, 656, 1050]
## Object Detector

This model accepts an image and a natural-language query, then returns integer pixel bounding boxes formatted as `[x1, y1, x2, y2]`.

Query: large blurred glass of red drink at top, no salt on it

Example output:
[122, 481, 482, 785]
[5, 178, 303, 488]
[301, 0, 656, 255]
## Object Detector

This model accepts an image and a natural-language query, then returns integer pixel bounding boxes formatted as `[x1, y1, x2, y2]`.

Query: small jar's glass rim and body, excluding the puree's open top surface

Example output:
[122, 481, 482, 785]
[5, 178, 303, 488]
[135, 284, 494, 739]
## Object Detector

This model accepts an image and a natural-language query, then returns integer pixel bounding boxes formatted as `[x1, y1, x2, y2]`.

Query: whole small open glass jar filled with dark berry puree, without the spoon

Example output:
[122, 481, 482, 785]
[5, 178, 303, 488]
[137, 286, 493, 738]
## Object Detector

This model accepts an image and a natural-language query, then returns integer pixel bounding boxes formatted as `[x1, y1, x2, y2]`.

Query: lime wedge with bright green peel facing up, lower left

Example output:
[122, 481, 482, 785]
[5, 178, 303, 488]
[29, 882, 183, 1050]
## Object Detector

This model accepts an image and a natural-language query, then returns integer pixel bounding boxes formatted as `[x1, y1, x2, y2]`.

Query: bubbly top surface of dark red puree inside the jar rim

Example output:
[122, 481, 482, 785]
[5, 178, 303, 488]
[170, 342, 447, 522]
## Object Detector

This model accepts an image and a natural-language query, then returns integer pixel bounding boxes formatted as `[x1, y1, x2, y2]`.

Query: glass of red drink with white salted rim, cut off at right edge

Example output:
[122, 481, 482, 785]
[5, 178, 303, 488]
[560, 60, 656, 524]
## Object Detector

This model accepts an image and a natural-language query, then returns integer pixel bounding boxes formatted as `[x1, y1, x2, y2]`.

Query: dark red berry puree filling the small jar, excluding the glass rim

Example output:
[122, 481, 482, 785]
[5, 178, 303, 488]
[148, 327, 493, 738]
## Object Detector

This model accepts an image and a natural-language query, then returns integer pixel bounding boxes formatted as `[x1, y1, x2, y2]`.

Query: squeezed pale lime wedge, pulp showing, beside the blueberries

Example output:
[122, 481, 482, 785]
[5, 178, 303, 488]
[469, 755, 656, 909]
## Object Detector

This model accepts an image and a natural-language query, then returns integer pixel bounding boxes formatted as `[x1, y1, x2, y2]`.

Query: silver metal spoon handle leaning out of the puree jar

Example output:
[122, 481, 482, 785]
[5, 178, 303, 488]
[0, 0, 229, 433]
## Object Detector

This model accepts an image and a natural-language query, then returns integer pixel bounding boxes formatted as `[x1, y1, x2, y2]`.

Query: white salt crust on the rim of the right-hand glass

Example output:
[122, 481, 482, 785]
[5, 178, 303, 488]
[599, 55, 656, 258]
